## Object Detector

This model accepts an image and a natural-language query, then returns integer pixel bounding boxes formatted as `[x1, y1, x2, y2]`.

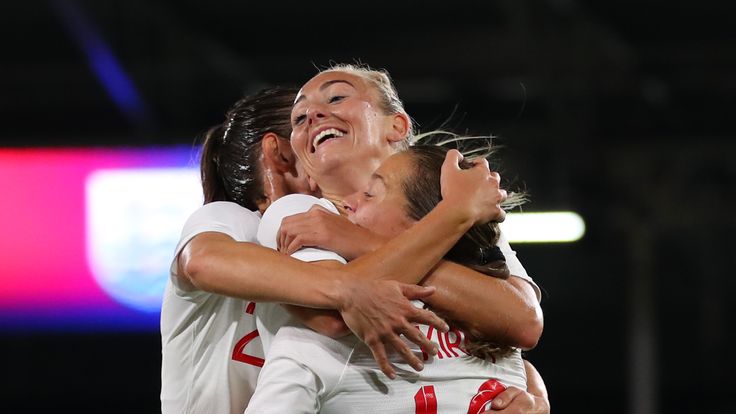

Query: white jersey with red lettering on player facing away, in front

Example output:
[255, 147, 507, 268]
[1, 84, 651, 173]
[245, 196, 539, 414]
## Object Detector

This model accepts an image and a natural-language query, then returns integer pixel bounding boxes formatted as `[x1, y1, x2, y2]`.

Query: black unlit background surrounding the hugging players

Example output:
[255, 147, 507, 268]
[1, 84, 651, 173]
[0, 0, 736, 414]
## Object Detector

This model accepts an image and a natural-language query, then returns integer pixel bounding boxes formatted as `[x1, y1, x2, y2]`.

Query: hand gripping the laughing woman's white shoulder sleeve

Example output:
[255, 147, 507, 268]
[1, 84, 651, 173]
[276, 204, 384, 261]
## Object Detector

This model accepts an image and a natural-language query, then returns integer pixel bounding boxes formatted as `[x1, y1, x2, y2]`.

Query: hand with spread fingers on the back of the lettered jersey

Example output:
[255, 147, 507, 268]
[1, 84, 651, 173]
[338, 279, 449, 379]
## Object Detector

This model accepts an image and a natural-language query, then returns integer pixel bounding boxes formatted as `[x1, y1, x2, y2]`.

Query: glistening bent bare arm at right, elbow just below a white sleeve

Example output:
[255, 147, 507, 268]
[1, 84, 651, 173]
[422, 261, 543, 349]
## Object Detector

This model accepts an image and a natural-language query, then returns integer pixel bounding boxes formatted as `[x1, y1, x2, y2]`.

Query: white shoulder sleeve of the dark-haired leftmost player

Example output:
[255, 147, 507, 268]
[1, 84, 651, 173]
[170, 201, 260, 286]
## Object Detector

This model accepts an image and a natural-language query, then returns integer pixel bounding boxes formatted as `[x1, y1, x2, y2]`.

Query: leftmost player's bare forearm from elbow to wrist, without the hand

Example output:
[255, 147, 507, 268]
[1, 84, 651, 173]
[178, 232, 345, 309]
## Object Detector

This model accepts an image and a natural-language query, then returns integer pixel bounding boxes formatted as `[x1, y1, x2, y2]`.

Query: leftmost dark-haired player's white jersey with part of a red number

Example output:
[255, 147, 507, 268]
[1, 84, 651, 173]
[161, 201, 263, 414]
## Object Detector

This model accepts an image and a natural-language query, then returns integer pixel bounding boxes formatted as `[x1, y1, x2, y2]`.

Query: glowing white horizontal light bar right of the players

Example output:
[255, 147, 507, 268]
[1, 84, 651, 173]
[501, 211, 585, 243]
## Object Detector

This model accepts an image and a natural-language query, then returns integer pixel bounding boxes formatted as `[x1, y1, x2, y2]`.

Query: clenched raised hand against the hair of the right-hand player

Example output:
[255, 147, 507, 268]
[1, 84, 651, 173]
[440, 149, 507, 224]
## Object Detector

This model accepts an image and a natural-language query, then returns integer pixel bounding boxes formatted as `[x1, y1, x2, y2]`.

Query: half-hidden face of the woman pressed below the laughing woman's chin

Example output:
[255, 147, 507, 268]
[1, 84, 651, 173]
[345, 153, 415, 237]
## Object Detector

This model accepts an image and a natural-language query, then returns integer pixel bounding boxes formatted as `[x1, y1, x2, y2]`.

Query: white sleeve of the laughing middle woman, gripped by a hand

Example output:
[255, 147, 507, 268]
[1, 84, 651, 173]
[257, 194, 347, 264]
